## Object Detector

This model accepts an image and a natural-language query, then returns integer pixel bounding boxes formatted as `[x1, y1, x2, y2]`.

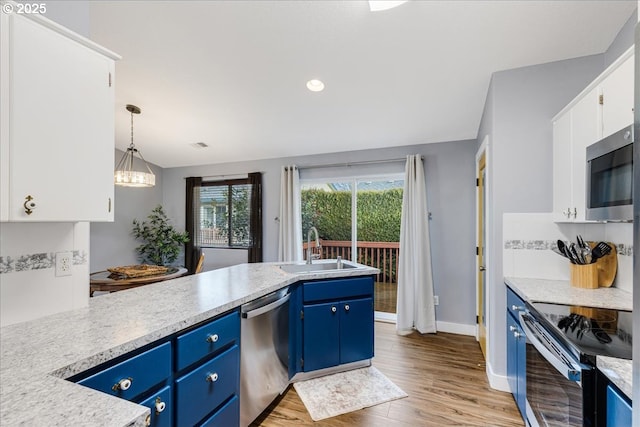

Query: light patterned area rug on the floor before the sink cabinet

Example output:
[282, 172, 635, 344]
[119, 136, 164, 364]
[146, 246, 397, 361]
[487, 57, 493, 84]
[293, 366, 408, 421]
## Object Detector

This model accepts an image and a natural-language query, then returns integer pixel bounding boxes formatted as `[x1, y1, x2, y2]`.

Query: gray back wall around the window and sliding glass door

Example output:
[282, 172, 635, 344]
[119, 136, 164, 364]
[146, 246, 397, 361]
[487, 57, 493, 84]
[163, 140, 476, 325]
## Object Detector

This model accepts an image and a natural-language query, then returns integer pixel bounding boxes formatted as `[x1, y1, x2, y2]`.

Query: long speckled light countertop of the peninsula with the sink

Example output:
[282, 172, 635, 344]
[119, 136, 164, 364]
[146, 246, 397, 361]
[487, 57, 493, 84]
[0, 263, 378, 427]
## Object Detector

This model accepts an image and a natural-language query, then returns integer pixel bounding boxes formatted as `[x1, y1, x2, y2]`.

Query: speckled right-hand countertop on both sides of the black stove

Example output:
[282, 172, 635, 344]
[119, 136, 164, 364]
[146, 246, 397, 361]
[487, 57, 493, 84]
[504, 277, 633, 399]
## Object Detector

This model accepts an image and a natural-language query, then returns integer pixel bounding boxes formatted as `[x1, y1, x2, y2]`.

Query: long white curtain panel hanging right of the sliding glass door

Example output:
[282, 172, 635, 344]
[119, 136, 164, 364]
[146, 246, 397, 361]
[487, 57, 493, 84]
[396, 155, 436, 335]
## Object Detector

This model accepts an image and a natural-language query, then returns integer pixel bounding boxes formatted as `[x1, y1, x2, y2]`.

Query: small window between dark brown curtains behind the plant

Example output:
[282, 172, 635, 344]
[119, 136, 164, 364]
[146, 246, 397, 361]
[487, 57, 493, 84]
[198, 179, 252, 248]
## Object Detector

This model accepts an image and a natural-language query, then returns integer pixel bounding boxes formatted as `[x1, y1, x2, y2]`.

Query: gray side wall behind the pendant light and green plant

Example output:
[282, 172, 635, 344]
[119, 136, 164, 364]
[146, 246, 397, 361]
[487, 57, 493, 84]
[89, 150, 162, 272]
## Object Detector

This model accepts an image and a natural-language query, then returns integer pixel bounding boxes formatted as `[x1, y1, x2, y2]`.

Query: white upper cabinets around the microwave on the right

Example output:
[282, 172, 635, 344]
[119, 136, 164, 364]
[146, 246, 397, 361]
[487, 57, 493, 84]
[552, 49, 634, 222]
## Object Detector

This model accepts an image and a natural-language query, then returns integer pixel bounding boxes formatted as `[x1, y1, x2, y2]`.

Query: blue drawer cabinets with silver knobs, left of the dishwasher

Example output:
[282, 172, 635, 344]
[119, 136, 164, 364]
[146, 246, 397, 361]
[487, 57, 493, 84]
[70, 310, 240, 427]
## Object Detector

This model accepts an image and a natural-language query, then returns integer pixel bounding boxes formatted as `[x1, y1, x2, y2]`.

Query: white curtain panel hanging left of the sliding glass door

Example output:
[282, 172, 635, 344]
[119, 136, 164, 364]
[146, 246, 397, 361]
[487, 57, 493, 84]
[278, 166, 302, 261]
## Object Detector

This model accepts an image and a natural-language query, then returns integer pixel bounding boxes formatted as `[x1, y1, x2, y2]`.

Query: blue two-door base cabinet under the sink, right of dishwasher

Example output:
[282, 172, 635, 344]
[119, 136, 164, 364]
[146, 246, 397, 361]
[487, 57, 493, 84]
[290, 276, 374, 376]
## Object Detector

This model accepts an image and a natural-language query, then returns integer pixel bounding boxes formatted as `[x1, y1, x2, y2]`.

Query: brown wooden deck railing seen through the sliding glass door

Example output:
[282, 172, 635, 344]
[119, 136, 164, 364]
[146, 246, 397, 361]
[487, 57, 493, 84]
[302, 240, 400, 283]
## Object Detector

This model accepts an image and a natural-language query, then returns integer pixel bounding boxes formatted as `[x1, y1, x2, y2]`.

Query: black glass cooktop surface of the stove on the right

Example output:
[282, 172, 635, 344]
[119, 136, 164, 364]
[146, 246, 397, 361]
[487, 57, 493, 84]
[532, 303, 633, 364]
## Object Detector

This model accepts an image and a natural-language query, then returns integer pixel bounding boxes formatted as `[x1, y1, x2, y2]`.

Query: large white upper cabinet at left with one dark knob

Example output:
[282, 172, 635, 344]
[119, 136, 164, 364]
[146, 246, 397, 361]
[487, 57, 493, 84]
[0, 14, 118, 222]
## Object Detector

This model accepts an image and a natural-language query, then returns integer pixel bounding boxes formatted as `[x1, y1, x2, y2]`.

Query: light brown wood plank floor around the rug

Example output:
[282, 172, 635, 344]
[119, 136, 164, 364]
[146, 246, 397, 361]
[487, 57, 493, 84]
[254, 322, 523, 427]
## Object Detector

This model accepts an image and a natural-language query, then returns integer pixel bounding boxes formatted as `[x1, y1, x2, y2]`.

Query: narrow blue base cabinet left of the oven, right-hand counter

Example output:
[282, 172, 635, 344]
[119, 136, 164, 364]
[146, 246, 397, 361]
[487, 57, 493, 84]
[506, 287, 527, 420]
